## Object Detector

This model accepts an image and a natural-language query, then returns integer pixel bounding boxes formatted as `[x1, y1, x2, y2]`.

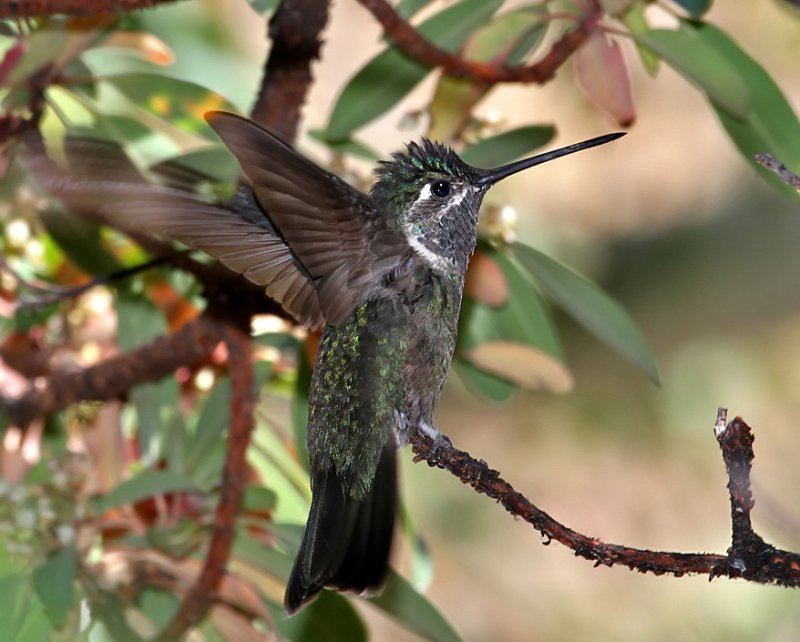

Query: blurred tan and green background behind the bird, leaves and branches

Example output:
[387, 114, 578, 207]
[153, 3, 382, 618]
[4, 0, 800, 642]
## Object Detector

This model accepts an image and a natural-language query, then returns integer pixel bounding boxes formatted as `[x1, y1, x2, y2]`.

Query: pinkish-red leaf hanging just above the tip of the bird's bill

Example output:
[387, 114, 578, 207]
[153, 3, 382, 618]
[575, 32, 636, 127]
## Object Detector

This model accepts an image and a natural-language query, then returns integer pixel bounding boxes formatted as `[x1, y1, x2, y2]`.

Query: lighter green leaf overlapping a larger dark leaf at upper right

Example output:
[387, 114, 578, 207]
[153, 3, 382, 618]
[639, 20, 754, 119]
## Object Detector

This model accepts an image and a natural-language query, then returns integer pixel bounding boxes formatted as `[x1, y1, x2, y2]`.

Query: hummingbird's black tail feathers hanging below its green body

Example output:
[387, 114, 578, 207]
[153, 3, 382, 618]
[283, 440, 397, 615]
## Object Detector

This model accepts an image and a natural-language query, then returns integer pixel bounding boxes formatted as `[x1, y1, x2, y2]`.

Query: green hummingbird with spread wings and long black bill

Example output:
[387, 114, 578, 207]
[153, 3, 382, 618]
[25, 112, 623, 615]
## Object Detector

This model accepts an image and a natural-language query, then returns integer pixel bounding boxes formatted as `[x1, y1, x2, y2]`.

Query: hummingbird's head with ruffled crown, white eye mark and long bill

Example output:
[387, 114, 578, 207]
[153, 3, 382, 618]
[370, 133, 624, 275]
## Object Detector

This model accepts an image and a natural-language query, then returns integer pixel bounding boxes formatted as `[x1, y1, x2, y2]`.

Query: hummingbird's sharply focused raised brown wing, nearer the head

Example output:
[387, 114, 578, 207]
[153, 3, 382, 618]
[206, 112, 410, 325]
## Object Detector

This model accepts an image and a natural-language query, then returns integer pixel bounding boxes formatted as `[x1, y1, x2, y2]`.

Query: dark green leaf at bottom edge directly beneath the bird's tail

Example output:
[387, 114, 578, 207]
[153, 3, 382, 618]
[270, 591, 367, 642]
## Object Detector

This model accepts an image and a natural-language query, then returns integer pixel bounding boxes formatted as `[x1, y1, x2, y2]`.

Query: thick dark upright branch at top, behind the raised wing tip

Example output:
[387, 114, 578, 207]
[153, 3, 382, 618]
[251, 0, 330, 141]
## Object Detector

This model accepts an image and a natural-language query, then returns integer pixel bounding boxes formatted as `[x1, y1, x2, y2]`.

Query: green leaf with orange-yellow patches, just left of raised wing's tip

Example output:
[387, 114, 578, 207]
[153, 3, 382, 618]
[102, 74, 237, 140]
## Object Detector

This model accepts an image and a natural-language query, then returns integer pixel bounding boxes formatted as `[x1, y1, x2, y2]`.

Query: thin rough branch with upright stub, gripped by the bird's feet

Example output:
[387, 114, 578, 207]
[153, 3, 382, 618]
[412, 410, 800, 586]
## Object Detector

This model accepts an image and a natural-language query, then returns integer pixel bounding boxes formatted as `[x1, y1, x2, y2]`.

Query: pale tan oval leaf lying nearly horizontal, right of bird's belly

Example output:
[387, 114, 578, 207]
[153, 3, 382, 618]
[464, 341, 572, 393]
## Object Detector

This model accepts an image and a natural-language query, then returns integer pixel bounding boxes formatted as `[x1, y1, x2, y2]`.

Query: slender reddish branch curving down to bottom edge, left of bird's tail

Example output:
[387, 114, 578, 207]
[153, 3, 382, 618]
[156, 325, 254, 642]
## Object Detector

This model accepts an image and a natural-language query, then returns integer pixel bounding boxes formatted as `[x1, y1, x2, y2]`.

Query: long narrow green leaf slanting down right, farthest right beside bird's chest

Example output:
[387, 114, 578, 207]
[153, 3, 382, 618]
[513, 243, 659, 383]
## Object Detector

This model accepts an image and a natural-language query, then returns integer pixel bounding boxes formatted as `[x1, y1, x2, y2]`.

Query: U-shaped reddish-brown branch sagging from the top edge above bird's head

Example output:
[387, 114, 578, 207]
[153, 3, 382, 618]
[358, 0, 603, 85]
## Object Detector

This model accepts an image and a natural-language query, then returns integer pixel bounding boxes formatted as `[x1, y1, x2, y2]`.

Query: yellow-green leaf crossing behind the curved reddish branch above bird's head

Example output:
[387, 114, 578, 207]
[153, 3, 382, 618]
[428, 7, 549, 142]
